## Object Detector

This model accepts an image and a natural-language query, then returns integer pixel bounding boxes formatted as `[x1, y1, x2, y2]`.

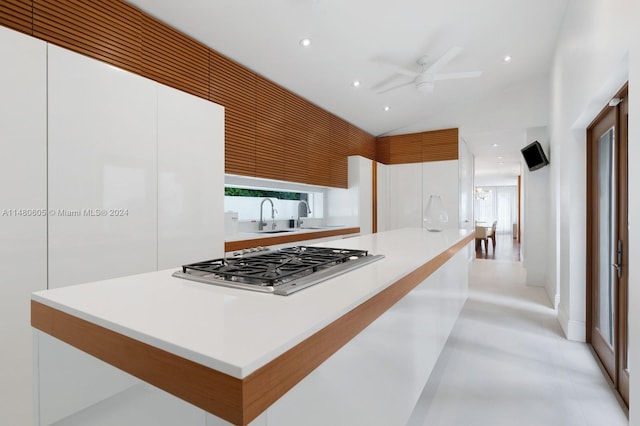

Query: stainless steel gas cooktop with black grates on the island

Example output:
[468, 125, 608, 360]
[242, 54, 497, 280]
[173, 246, 384, 296]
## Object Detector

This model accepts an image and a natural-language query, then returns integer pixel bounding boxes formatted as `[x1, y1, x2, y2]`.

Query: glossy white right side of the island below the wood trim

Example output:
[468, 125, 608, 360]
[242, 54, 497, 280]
[266, 251, 468, 426]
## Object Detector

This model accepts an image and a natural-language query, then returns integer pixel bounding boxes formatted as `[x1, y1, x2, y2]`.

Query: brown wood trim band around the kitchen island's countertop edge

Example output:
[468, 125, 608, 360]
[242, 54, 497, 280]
[31, 234, 474, 425]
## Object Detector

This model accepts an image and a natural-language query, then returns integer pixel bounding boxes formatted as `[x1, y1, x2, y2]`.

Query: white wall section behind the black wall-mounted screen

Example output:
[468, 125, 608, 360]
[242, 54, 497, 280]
[521, 127, 556, 303]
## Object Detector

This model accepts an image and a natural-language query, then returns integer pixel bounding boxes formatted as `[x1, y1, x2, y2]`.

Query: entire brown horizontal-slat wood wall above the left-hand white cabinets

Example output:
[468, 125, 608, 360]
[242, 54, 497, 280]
[0, 0, 376, 187]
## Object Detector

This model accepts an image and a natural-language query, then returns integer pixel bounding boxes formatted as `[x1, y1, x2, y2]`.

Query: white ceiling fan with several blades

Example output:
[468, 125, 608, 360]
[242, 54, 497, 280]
[374, 46, 482, 94]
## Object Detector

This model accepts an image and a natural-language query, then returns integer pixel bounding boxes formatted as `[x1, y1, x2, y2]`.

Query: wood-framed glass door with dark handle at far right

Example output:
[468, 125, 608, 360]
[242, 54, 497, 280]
[586, 86, 629, 406]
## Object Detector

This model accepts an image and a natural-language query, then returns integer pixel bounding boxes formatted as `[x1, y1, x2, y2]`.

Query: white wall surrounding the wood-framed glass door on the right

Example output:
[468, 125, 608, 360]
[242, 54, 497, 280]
[550, 0, 640, 425]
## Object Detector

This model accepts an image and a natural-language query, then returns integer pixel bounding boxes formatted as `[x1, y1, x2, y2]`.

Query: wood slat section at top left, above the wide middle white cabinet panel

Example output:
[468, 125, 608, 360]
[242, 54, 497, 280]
[33, 0, 142, 74]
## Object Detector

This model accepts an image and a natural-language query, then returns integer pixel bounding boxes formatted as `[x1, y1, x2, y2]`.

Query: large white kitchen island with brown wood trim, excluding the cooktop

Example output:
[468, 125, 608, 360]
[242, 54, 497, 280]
[31, 229, 473, 426]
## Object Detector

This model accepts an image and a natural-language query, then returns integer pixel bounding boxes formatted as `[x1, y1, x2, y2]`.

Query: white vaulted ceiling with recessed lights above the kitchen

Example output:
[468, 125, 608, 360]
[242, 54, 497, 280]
[129, 0, 568, 180]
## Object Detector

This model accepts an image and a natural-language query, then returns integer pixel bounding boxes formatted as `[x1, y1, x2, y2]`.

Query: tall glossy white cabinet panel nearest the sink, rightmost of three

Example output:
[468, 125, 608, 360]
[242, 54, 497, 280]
[158, 86, 224, 269]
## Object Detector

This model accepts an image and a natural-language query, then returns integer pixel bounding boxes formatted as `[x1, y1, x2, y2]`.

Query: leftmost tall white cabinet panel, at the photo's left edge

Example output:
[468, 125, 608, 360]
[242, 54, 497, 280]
[0, 26, 47, 425]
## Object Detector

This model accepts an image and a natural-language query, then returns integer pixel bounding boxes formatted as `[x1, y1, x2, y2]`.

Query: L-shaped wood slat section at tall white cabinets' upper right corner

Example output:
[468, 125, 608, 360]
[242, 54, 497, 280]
[209, 50, 256, 176]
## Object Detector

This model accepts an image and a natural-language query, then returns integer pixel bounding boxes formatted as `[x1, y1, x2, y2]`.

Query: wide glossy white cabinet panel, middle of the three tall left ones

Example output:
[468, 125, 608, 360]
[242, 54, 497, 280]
[48, 45, 157, 287]
